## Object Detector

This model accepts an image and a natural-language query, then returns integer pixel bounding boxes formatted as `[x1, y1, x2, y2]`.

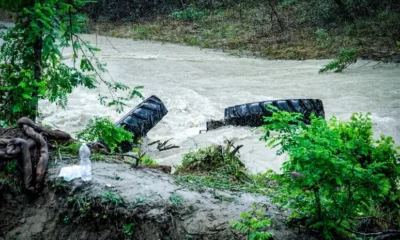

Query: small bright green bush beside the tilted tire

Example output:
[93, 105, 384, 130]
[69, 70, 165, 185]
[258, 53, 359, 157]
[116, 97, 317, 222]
[76, 117, 133, 152]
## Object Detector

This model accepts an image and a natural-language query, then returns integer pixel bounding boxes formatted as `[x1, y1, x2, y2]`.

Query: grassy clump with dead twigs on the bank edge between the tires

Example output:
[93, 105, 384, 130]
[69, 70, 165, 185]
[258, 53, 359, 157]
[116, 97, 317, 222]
[175, 141, 271, 194]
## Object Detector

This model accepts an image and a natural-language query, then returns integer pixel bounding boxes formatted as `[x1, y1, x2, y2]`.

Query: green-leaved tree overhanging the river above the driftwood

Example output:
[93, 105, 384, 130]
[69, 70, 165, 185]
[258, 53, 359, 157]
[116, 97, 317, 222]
[0, 0, 140, 123]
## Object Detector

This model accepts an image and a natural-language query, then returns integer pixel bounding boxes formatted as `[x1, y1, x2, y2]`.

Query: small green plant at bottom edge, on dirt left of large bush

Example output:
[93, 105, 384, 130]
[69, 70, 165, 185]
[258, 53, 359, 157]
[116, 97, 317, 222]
[230, 203, 273, 240]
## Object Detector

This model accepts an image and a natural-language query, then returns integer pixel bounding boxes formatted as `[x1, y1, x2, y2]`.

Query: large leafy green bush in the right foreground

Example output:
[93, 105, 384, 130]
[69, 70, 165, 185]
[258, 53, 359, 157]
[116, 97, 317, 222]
[264, 108, 400, 239]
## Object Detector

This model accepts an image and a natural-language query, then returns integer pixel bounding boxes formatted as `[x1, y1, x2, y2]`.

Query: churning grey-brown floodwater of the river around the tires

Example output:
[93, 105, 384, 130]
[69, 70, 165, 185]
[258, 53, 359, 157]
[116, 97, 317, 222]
[26, 35, 400, 172]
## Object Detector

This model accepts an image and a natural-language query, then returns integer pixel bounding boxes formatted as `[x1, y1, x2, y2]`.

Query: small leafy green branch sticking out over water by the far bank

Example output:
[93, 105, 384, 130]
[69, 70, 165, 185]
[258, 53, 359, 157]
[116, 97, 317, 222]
[319, 48, 360, 73]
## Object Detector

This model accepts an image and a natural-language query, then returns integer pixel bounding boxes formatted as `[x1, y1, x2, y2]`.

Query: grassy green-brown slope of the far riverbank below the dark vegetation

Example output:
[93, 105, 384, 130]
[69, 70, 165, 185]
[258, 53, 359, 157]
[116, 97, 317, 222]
[90, 6, 400, 62]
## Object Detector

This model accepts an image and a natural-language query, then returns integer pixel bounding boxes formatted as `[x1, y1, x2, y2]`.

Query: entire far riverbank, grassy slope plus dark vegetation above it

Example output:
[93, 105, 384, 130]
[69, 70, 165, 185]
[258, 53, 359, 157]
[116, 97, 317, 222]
[83, 0, 400, 62]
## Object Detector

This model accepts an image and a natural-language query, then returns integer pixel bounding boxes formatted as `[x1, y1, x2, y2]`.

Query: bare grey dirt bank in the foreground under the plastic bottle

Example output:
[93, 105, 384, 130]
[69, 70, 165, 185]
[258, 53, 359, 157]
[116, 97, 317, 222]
[0, 159, 310, 240]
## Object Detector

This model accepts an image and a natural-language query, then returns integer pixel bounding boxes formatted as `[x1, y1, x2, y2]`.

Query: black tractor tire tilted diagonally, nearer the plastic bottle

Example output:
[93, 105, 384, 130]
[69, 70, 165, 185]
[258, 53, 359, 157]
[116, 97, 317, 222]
[115, 96, 168, 152]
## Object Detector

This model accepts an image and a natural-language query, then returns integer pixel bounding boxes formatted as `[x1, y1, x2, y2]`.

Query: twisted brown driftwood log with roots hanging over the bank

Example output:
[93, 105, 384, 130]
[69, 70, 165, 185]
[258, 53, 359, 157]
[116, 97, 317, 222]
[0, 117, 71, 193]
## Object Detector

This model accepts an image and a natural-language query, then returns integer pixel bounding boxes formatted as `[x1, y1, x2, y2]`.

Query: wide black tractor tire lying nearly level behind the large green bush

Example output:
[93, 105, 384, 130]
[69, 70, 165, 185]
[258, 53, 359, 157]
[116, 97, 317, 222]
[224, 99, 325, 127]
